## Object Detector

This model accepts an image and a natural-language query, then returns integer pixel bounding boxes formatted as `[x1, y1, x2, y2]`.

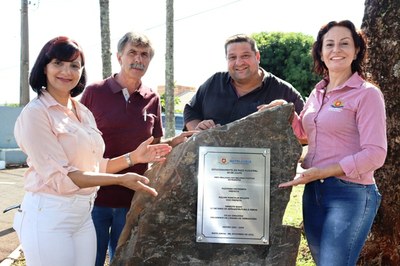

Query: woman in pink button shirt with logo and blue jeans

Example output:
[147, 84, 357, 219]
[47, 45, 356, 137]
[262, 20, 387, 266]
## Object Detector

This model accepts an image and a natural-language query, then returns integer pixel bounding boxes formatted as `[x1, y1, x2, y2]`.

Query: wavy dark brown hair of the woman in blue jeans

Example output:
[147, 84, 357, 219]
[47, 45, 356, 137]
[311, 20, 367, 79]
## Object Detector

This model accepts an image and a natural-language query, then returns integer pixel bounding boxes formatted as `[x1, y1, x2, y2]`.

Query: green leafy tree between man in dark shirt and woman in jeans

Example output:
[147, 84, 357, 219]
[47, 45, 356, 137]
[252, 32, 321, 97]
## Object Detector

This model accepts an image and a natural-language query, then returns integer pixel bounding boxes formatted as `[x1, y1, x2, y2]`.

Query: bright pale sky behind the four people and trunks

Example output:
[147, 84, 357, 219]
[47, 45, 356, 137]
[0, 0, 365, 104]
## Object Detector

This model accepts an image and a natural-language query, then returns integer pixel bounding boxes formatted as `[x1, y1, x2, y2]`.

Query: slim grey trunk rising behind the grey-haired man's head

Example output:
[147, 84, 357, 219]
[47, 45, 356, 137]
[99, 0, 112, 79]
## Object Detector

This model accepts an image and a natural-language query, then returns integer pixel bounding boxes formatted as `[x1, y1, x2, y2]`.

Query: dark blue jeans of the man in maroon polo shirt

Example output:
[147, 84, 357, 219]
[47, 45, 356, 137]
[92, 206, 129, 266]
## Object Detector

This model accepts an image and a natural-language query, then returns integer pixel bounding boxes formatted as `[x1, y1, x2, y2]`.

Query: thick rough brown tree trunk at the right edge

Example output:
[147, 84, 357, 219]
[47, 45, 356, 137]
[359, 0, 400, 266]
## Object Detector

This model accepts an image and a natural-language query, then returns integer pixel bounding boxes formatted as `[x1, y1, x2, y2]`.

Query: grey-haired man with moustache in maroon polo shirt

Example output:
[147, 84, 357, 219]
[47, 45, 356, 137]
[81, 32, 190, 266]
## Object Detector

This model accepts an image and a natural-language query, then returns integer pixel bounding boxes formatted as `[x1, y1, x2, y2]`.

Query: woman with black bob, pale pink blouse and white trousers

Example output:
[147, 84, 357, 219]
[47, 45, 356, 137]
[14, 36, 171, 266]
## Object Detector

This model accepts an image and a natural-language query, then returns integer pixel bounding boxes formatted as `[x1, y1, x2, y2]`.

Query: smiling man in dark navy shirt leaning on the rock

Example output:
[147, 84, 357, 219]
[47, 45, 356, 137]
[184, 34, 304, 130]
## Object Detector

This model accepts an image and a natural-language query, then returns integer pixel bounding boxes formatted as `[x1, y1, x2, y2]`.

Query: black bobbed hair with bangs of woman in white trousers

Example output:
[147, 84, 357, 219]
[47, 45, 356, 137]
[29, 36, 86, 97]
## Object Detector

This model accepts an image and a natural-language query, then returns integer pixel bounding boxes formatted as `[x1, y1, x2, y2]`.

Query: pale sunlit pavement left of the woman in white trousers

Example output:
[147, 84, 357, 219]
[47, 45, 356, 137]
[0, 168, 26, 262]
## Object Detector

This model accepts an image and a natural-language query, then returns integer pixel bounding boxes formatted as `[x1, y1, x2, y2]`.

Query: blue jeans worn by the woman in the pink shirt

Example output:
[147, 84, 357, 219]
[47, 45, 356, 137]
[303, 177, 381, 266]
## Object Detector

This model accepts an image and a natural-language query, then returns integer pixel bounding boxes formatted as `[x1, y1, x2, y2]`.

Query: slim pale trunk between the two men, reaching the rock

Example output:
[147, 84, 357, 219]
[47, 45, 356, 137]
[165, 0, 175, 138]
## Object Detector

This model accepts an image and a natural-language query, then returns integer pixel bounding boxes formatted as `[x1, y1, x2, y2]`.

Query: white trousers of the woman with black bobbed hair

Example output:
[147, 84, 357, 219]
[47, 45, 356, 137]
[13, 192, 97, 266]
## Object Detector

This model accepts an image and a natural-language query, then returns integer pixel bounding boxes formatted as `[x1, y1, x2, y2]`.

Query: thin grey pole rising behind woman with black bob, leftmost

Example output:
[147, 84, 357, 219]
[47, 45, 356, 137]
[19, 0, 29, 106]
